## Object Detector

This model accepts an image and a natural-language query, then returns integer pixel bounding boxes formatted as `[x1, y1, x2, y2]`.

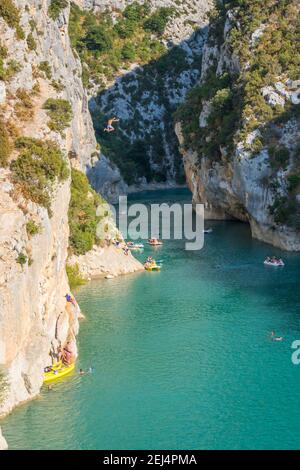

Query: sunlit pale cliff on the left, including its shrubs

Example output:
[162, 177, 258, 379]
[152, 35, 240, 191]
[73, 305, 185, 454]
[0, 0, 141, 447]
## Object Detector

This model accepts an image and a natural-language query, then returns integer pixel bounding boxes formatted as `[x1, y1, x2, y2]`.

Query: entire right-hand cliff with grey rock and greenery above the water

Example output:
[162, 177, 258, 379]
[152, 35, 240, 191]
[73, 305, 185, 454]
[176, 1, 300, 250]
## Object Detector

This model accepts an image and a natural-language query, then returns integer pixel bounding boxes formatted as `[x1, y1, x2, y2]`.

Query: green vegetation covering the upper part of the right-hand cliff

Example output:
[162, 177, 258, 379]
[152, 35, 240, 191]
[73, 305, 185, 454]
[176, 0, 300, 229]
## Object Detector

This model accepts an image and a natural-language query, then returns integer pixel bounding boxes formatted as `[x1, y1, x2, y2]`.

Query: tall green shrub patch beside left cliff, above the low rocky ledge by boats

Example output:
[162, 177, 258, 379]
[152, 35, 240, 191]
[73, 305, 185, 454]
[69, 169, 103, 255]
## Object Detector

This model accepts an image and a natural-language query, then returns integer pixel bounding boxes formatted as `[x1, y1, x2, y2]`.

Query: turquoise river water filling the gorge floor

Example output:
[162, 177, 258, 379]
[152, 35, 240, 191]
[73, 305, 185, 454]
[1, 191, 300, 449]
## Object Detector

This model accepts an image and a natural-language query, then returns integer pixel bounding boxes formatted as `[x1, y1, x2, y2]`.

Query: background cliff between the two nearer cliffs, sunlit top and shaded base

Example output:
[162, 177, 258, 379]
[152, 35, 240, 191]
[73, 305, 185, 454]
[68, 0, 212, 201]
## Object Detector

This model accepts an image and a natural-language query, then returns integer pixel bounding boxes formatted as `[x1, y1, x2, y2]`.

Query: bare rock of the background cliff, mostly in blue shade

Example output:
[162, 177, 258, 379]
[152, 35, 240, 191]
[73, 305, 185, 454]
[77, 0, 212, 198]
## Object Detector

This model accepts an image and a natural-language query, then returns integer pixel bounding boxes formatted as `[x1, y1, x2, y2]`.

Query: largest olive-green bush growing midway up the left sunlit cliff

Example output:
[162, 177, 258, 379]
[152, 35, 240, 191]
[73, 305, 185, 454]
[11, 137, 69, 215]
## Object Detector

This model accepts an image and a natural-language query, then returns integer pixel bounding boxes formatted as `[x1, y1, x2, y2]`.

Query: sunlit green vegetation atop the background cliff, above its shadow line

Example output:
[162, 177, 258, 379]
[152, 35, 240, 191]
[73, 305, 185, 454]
[69, 1, 174, 86]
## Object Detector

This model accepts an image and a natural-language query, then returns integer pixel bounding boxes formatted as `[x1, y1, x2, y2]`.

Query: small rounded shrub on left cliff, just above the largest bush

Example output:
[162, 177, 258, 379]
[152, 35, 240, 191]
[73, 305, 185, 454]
[43, 98, 73, 133]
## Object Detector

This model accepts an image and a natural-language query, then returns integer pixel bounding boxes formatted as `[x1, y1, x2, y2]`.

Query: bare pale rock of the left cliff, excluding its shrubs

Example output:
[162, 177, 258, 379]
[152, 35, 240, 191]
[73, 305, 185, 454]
[0, 0, 96, 420]
